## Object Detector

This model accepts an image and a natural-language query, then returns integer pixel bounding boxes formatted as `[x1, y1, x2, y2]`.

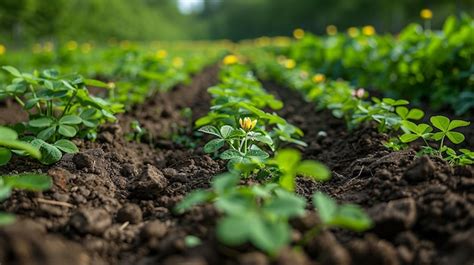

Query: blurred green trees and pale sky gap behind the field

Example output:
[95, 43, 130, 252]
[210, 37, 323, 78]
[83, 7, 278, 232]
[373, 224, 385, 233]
[0, 0, 474, 46]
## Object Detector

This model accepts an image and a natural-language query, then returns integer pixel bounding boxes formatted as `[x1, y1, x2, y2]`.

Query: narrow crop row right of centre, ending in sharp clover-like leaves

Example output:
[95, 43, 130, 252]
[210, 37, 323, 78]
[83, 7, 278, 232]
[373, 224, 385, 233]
[252, 49, 474, 165]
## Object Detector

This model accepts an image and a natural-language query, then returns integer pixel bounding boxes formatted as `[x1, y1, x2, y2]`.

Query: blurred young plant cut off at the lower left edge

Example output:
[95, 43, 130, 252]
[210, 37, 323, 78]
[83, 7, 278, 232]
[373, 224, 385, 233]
[0, 173, 52, 225]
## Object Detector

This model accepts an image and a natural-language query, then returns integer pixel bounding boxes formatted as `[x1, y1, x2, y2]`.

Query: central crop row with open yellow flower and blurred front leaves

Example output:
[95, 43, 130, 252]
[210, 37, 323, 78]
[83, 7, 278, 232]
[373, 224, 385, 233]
[176, 55, 371, 254]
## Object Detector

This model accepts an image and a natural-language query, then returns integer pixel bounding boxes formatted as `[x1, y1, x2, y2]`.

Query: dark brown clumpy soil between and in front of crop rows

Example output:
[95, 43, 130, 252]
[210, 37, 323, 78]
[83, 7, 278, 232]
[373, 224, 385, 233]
[0, 66, 474, 265]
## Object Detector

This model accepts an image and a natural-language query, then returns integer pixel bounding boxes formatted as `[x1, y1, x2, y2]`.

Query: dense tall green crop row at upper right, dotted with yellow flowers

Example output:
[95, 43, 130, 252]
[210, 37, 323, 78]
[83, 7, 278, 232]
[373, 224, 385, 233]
[273, 15, 474, 114]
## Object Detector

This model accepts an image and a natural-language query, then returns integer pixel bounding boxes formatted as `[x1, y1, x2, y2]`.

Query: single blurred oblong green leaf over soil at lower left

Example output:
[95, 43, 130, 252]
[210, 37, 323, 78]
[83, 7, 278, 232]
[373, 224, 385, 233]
[3, 173, 52, 191]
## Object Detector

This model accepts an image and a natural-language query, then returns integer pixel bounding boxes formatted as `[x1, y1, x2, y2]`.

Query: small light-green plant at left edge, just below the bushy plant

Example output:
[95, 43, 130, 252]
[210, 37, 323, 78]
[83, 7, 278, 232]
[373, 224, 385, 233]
[0, 126, 41, 166]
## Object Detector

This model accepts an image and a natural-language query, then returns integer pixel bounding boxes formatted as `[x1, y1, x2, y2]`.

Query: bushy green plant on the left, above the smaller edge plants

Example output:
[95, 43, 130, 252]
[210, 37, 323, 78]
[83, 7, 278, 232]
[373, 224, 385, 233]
[0, 66, 123, 164]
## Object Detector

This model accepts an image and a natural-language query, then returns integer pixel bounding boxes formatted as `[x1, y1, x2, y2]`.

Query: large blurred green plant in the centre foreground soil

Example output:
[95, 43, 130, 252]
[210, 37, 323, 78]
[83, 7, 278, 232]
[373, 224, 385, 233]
[176, 173, 306, 255]
